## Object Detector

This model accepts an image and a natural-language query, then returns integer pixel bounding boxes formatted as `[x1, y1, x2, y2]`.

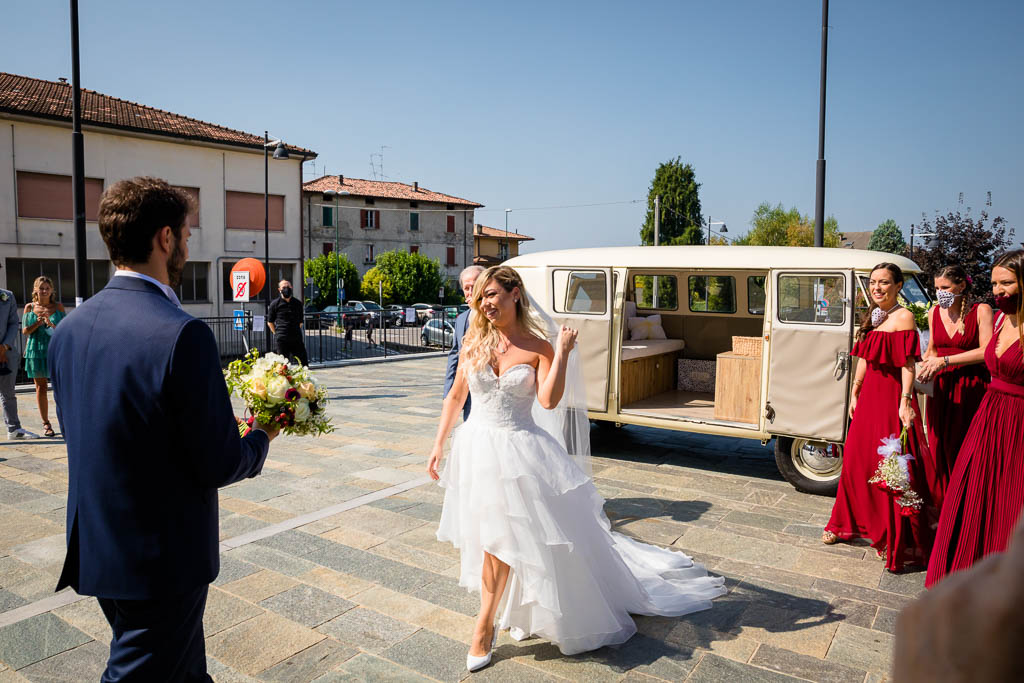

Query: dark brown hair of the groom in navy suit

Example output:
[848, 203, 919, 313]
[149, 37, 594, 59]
[99, 176, 195, 265]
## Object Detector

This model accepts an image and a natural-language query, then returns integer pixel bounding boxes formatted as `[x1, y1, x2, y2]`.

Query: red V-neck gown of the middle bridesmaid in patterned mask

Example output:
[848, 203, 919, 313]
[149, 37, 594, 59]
[925, 306, 990, 508]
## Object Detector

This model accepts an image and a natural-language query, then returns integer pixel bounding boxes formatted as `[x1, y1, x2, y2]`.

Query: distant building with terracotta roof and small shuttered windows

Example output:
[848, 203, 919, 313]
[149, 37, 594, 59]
[303, 175, 483, 282]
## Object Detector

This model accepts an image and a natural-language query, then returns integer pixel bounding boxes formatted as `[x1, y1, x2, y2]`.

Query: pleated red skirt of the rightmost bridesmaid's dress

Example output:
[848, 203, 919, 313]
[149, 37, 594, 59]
[925, 390, 1024, 588]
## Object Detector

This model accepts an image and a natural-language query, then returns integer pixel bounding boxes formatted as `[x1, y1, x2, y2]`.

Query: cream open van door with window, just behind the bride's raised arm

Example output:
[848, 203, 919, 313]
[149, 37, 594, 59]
[546, 266, 613, 413]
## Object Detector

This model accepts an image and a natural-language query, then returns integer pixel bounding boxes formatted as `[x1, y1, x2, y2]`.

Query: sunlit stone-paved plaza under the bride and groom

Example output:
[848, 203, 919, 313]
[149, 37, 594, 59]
[0, 357, 924, 683]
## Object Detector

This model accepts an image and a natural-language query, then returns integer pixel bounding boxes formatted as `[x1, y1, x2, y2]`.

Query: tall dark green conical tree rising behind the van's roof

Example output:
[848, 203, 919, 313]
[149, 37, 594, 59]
[640, 157, 703, 245]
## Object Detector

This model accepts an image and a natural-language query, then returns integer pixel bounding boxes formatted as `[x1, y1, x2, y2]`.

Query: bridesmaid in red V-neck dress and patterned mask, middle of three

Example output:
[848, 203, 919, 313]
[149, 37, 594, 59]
[918, 265, 992, 508]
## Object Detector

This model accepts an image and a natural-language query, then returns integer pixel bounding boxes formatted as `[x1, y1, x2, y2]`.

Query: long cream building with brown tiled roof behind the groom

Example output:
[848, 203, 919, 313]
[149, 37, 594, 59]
[0, 74, 315, 316]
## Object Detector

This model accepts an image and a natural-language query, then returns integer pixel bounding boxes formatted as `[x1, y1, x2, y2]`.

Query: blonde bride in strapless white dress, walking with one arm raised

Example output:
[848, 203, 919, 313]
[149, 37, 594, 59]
[428, 266, 725, 671]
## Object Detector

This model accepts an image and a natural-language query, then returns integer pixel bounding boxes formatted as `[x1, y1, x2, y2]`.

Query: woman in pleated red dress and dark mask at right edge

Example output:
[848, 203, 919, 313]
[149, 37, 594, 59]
[925, 250, 1024, 587]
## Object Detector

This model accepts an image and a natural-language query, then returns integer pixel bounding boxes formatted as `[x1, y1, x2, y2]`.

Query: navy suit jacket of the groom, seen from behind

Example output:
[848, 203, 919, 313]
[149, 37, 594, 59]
[48, 278, 269, 600]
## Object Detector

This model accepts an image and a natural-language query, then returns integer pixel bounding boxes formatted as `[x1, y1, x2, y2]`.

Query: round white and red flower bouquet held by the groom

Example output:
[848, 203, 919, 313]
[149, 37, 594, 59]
[224, 349, 334, 436]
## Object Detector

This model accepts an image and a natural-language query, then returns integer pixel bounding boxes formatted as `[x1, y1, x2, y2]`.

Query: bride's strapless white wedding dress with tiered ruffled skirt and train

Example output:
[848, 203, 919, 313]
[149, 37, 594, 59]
[437, 365, 725, 654]
